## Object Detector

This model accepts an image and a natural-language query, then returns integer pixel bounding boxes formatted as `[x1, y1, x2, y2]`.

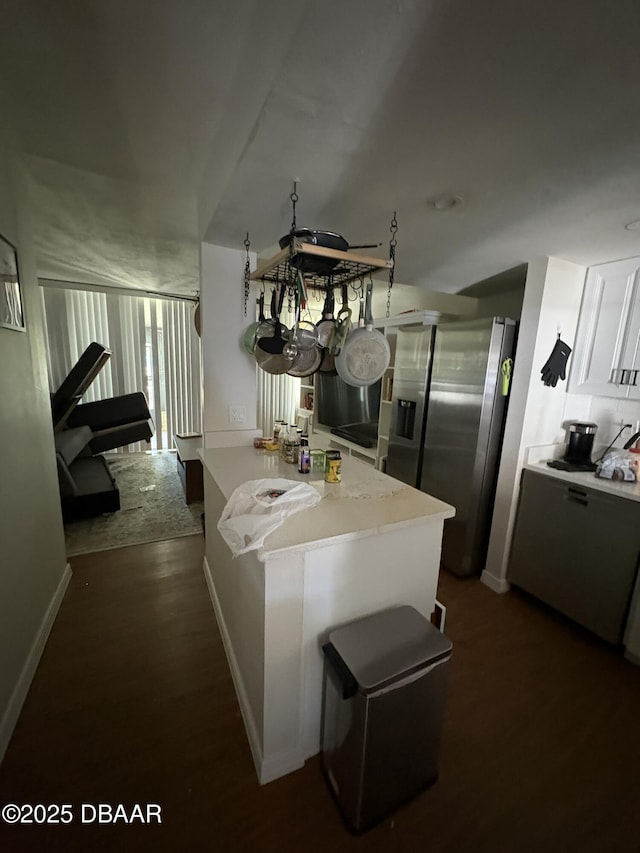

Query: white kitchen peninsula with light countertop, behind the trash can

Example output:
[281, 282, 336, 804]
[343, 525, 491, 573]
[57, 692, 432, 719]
[201, 447, 455, 783]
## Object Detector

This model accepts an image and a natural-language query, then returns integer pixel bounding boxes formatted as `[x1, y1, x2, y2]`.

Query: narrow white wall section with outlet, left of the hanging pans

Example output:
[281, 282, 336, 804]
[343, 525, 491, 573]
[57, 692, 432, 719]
[200, 243, 258, 447]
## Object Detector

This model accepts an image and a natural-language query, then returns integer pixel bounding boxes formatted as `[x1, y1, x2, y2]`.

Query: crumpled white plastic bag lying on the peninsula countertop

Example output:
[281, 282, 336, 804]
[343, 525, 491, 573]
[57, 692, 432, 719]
[218, 479, 320, 557]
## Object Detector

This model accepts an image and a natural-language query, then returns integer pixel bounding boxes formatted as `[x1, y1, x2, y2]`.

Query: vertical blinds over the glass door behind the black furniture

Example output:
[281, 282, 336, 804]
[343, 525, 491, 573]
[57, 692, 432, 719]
[42, 285, 202, 450]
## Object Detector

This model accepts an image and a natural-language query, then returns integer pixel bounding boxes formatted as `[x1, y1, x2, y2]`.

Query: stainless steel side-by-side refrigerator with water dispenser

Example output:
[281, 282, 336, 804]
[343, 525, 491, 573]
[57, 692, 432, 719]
[386, 317, 515, 576]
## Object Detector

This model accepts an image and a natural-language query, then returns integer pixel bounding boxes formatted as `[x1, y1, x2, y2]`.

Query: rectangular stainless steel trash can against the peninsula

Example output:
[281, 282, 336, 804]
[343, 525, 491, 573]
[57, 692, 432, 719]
[321, 606, 452, 832]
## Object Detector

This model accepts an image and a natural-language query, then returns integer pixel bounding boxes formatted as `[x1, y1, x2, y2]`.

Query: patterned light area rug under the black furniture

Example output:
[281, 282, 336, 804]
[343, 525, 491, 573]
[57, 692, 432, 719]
[65, 450, 204, 557]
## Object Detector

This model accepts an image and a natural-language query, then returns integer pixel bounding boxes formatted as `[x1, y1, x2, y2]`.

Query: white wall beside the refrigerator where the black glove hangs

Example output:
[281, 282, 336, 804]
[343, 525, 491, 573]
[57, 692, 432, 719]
[482, 258, 590, 592]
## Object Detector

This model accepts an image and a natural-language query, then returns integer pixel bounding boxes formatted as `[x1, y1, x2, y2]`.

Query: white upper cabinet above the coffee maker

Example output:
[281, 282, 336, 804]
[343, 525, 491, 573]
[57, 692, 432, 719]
[568, 258, 640, 400]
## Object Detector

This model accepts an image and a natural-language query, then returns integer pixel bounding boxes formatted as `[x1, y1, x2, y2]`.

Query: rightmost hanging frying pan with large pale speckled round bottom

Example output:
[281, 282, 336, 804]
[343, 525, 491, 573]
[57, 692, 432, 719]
[336, 282, 391, 387]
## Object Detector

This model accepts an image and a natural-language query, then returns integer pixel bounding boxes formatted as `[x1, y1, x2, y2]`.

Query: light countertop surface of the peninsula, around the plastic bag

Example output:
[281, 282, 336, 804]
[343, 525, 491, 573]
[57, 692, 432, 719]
[200, 447, 455, 554]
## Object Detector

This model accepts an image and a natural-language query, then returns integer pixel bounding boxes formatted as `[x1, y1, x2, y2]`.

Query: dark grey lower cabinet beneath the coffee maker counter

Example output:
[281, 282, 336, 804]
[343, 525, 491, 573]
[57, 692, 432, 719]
[507, 470, 640, 645]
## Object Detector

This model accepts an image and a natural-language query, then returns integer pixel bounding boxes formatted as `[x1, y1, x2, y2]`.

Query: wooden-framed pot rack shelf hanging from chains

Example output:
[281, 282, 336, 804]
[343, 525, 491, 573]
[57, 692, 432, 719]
[250, 238, 393, 289]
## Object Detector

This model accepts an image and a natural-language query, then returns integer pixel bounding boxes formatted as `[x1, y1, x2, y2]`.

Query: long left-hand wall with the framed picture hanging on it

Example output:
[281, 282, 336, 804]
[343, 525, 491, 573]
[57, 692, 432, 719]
[0, 149, 69, 759]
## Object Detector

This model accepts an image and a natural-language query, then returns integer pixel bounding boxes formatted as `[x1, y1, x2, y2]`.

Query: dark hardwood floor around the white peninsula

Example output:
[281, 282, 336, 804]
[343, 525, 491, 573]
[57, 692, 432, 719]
[0, 536, 640, 853]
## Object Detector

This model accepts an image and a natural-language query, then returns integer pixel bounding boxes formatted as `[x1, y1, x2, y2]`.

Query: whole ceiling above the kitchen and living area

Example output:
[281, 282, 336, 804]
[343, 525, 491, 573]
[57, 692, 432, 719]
[0, 0, 640, 293]
